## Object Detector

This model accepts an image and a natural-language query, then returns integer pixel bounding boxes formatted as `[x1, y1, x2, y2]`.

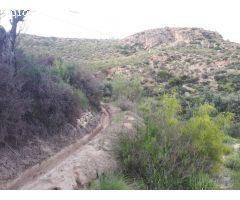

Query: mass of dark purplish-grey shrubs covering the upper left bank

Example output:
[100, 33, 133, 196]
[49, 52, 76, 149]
[0, 49, 102, 146]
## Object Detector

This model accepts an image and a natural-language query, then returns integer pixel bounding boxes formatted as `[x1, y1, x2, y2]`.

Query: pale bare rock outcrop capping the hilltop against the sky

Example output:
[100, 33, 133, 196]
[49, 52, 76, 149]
[122, 27, 223, 49]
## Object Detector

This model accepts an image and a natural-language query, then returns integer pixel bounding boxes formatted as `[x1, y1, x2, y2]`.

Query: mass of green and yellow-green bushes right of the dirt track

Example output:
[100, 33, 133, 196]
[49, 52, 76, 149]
[85, 73, 238, 189]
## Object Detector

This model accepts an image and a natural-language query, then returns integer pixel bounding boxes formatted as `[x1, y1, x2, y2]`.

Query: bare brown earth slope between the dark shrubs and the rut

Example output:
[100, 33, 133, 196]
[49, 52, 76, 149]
[0, 109, 100, 189]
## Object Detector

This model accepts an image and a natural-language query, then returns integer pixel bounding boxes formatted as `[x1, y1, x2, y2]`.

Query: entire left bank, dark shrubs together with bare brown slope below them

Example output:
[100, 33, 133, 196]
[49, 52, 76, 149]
[0, 45, 102, 181]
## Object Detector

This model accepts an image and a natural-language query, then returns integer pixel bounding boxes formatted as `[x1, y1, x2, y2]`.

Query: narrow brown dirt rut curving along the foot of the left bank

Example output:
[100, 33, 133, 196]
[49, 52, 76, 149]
[3, 106, 111, 189]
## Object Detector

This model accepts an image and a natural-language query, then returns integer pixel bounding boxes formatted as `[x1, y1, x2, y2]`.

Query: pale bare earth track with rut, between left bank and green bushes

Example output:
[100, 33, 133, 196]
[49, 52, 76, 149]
[2, 104, 141, 189]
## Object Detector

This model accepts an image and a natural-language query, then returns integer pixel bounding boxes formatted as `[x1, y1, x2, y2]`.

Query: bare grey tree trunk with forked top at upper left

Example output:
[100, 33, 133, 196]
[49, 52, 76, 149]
[0, 10, 29, 66]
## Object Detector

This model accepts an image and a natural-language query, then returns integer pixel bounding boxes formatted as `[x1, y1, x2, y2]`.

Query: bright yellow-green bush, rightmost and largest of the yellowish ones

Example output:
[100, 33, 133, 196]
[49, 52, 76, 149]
[184, 104, 233, 171]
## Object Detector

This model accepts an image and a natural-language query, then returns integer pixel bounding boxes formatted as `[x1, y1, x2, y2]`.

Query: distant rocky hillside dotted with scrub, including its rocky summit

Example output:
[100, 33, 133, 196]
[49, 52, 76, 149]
[18, 28, 240, 116]
